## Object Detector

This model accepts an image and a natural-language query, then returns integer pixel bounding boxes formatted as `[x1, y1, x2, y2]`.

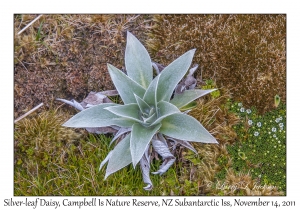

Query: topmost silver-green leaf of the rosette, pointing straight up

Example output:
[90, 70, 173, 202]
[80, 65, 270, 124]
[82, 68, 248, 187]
[125, 32, 153, 88]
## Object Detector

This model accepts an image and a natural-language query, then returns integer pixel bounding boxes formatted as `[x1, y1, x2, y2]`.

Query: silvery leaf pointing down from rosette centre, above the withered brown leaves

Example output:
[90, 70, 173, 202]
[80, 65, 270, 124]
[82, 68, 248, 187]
[130, 123, 161, 167]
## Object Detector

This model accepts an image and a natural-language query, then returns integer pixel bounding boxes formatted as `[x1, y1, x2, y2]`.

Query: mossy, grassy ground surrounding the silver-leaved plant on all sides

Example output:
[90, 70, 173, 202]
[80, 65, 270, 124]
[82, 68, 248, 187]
[14, 14, 287, 195]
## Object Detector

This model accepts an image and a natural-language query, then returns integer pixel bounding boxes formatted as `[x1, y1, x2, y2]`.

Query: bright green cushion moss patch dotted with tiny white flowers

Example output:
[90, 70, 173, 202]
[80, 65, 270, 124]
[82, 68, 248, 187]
[227, 103, 286, 194]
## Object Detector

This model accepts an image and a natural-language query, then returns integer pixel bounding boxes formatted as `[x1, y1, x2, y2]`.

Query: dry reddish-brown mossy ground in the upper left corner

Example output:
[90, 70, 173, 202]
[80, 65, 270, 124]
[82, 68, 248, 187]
[14, 15, 149, 117]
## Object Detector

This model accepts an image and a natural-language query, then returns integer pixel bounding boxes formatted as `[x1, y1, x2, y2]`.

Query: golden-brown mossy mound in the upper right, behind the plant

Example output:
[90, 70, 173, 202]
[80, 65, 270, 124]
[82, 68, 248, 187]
[147, 14, 286, 114]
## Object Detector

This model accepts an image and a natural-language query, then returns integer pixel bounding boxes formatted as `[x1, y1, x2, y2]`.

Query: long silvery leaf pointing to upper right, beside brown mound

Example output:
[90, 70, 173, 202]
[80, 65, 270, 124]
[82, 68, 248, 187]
[157, 49, 195, 102]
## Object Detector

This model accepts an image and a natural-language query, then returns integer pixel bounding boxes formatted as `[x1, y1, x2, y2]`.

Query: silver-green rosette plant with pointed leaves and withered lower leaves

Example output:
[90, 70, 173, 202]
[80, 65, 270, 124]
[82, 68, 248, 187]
[63, 32, 217, 190]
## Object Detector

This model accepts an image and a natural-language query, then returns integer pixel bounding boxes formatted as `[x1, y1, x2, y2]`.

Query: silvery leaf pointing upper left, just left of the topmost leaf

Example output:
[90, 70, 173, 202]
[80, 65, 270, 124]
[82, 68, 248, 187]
[107, 64, 146, 104]
